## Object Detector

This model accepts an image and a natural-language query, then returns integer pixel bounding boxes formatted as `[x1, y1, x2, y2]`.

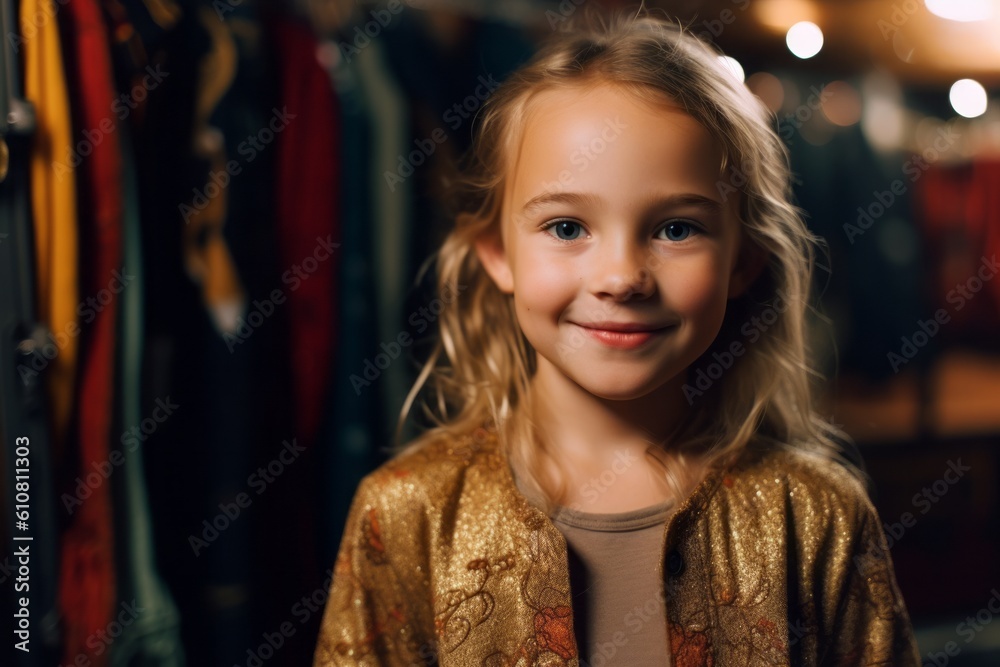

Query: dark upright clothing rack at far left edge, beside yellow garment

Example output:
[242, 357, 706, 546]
[0, 0, 61, 667]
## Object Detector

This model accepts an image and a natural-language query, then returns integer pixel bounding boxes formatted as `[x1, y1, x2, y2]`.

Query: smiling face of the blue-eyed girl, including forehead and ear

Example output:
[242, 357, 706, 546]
[477, 84, 745, 408]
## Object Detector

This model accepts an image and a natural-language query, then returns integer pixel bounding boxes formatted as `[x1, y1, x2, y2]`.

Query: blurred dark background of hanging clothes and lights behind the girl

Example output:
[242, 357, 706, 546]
[0, 0, 1000, 667]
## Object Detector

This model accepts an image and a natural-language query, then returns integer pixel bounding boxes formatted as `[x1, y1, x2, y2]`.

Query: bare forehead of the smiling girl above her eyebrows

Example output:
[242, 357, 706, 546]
[504, 83, 733, 219]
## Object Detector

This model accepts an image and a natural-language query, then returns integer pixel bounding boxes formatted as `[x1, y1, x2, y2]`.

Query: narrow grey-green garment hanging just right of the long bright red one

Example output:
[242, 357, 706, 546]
[97, 0, 184, 667]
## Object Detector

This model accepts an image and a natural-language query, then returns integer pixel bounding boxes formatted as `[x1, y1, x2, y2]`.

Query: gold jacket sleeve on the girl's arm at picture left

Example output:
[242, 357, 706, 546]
[313, 473, 435, 667]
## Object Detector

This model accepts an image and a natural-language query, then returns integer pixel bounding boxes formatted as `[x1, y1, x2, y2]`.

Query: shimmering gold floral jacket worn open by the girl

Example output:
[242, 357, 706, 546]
[314, 430, 920, 667]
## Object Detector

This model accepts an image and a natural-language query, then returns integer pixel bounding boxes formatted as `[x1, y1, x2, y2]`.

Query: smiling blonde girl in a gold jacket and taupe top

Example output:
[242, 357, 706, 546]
[315, 10, 919, 667]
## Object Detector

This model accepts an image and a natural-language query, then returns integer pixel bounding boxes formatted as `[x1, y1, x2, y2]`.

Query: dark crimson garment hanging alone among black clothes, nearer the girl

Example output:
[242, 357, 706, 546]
[272, 18, 341, 446]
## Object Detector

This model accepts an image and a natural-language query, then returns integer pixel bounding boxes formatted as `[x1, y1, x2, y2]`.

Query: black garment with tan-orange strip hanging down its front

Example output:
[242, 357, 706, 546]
[129, 3, 284, 667]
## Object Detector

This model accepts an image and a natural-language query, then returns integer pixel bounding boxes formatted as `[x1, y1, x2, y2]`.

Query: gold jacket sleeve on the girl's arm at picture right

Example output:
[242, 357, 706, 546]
[821, 495, 921, 667]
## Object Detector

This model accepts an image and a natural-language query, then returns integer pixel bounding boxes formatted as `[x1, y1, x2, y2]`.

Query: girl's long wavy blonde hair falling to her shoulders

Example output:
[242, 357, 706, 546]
[397, 7, 846, 509]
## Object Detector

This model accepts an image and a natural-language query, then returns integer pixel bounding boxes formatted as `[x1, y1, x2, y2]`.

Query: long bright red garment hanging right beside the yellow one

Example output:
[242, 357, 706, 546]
[59, 0, 122, 666]
